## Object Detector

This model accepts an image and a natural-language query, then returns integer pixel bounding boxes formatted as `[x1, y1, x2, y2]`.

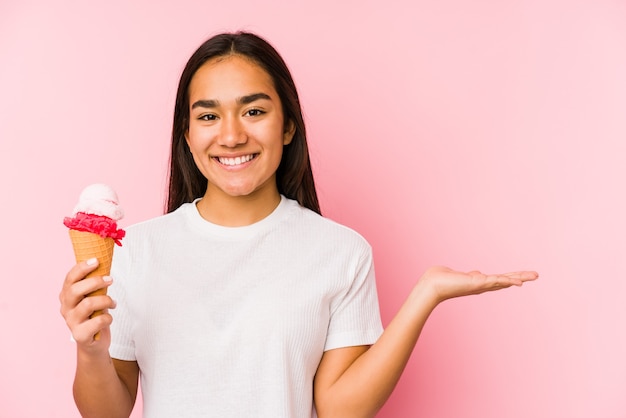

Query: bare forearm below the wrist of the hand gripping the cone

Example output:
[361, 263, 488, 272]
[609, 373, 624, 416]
[74, 350, 135, 418]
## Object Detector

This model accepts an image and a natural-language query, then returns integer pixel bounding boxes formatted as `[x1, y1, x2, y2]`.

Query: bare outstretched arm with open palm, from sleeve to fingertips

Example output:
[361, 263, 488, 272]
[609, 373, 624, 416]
[314, 267, 538, 418]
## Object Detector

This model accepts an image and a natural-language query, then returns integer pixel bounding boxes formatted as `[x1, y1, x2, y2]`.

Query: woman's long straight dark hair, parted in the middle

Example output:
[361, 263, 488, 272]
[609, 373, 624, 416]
[166, 32, 321, 213]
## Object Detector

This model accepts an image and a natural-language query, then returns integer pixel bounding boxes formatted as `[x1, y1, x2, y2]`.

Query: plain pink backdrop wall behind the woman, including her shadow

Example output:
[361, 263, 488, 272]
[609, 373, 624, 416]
[0, 0, 626, 418]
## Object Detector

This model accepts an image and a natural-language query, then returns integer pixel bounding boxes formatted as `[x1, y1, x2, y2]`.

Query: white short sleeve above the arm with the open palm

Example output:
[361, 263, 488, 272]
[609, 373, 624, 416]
[324, 245, 383, 351]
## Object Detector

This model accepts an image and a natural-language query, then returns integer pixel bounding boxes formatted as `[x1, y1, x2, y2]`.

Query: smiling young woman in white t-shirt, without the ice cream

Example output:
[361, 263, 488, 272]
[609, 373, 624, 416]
[60, 32, 537, 418]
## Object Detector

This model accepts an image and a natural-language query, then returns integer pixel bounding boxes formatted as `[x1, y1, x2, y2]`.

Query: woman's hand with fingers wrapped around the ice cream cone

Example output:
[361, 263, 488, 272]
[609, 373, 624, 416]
[59, 259, 115, 353]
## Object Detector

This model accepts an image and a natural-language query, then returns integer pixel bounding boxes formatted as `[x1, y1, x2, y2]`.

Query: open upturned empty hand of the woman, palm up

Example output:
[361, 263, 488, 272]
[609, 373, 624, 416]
[418, 267, 539, 303]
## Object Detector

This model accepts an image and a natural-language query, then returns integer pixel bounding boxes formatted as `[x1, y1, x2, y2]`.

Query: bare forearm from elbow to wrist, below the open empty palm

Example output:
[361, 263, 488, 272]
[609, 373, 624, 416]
[320, 283, 437, 418]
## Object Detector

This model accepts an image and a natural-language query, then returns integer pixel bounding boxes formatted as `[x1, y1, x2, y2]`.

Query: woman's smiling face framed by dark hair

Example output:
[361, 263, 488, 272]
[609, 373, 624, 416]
[185, 55, 295, 202]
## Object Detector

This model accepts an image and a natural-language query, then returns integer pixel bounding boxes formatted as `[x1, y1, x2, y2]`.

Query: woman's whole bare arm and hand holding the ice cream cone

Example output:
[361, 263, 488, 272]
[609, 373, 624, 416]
[59, 261, 139, 418]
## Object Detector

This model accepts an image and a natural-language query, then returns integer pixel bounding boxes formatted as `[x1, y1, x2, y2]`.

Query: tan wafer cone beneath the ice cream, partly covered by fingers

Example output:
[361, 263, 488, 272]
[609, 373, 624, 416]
[69, 229, 115, 340]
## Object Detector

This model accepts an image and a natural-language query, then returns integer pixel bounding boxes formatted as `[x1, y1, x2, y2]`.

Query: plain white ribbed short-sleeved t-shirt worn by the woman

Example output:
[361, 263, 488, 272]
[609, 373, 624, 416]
[109, 197, 382, 418]
